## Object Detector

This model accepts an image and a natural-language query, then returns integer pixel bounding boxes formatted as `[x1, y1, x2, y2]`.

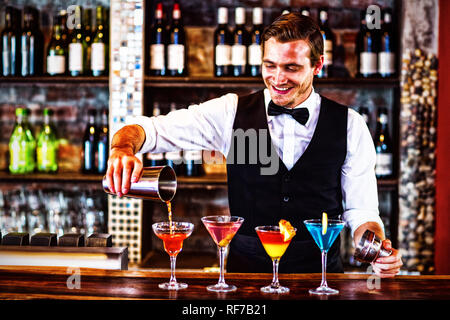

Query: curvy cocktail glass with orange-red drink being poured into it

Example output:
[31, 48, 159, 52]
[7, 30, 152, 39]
[152, 221, 194, 290]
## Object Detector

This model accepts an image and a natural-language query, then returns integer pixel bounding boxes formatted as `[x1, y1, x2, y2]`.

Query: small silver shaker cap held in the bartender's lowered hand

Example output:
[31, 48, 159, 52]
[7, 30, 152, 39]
[354, 230, 392, 263]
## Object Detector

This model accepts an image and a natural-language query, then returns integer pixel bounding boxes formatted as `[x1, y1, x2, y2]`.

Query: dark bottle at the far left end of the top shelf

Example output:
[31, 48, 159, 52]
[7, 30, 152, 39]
[1, 6, 20, 76]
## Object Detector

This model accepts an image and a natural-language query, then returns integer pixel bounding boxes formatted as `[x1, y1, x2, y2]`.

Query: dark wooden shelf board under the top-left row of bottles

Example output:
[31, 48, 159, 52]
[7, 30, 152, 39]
[0, 76, 109, 87]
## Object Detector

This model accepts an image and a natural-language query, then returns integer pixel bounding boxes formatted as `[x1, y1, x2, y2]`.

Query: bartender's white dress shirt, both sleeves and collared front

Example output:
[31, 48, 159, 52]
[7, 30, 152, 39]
[127, 89, 384, 236]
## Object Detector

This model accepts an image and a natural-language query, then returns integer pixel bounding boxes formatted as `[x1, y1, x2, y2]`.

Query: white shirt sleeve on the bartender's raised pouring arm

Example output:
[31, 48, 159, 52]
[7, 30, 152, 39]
[127, 93, 238, 154]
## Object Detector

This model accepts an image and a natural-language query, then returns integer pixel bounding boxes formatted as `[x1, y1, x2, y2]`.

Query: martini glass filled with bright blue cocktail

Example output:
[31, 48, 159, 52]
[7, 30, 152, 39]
[303, 219, 345, 295]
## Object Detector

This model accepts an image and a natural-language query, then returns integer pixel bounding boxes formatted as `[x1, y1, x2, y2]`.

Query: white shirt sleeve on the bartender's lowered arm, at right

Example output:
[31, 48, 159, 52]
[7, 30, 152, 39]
[341, 109, 384, 237]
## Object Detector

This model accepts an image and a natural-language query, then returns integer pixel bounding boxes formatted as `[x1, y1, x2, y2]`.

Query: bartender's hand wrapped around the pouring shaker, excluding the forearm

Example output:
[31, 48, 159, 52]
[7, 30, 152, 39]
[106, 147, 143, 197]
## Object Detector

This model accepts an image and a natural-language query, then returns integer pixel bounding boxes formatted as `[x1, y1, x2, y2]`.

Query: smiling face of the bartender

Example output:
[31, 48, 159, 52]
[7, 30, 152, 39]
[262, 38, 323, 108]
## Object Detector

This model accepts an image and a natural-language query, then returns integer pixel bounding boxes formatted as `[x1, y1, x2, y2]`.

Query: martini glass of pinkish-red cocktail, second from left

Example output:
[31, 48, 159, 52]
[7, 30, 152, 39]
[202, 216, 244, 292]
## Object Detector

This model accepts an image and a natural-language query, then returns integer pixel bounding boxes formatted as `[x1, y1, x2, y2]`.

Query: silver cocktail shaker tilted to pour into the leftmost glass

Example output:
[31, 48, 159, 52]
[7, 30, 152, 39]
[102, 166, 177, 202]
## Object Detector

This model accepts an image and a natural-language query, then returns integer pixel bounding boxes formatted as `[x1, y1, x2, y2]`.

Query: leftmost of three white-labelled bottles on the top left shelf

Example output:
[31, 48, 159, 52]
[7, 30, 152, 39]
[47, 15, 67, 76]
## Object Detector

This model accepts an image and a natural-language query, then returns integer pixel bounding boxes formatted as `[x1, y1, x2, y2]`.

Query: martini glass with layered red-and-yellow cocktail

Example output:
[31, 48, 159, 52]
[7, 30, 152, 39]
[255, 226, 297, 293]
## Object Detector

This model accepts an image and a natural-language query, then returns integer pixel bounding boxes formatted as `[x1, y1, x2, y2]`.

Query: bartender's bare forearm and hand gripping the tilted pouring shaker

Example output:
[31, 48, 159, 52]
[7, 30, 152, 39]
[106, 125, 145, 197]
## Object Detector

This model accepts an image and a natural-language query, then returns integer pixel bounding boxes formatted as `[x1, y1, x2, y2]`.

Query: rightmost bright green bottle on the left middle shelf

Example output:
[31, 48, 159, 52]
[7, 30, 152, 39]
[36, 108, 58, 172]
